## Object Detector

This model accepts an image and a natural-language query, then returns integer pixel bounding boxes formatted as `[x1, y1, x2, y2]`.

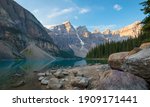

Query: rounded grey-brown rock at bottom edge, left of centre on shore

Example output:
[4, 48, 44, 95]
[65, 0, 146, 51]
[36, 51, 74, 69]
[47, 78, 63, 90]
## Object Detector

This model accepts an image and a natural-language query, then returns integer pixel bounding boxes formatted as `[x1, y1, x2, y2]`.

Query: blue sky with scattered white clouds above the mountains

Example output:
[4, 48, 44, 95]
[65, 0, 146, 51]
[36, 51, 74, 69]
[15, 0, 145, 31]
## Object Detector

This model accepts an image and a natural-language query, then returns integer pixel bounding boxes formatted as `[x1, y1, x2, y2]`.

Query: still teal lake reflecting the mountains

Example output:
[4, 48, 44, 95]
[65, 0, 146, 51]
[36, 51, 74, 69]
[0, 59, 107, 90]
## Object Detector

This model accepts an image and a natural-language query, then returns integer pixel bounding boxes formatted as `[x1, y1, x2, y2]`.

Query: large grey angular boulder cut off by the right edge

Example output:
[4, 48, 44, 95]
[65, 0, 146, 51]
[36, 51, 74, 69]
[122, 48, 150, 82]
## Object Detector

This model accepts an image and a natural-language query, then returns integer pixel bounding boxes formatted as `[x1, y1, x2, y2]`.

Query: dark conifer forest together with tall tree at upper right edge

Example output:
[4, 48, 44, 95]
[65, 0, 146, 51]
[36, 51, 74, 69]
[87, 0, 150, 58]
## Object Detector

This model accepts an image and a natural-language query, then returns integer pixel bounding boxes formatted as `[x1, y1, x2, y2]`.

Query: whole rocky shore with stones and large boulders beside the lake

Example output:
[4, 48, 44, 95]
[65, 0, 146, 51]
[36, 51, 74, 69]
[37, 43, 150, 90]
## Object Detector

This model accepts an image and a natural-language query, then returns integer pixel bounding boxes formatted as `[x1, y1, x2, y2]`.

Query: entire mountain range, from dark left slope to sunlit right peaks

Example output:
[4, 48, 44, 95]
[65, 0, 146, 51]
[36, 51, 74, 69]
[0, 0, 142, 59]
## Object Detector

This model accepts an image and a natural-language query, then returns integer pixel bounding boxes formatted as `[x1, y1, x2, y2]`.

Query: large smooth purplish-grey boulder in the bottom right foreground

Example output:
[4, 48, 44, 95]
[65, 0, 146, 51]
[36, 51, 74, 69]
[97, 70, 148, 90]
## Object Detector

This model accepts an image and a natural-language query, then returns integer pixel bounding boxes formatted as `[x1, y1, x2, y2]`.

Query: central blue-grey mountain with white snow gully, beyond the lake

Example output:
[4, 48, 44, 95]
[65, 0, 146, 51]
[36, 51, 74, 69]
[47, 21, 107, 57]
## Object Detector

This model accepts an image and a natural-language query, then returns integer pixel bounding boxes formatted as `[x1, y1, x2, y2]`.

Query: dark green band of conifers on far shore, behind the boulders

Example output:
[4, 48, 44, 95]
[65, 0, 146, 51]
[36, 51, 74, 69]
[87, 34, 150, 58]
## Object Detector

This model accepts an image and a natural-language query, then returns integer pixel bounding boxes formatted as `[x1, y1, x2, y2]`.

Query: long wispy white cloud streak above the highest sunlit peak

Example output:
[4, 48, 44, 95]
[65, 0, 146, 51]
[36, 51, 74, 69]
[48, 8, 74, 18]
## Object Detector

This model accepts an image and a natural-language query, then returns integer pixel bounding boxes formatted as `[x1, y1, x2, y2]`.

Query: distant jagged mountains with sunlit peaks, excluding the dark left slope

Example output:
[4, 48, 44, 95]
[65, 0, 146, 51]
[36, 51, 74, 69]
[47, 21, 142, 57]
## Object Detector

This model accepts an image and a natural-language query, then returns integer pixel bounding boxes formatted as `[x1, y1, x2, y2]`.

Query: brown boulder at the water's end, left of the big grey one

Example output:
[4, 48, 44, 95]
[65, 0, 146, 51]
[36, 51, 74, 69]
[108, 52, 129, 70]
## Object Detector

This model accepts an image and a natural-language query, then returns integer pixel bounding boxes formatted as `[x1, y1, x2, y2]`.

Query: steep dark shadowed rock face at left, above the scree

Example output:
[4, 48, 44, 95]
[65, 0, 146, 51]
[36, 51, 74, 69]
[0, 0, 58, 59]
